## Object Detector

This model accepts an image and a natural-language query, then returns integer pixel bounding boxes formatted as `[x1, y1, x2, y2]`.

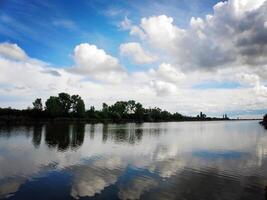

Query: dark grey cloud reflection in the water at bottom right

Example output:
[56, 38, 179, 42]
[141, 168, 264, 200]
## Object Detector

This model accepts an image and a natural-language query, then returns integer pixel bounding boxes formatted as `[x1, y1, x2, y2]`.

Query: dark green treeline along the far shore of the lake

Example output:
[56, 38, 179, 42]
[0, 93, 229, 123]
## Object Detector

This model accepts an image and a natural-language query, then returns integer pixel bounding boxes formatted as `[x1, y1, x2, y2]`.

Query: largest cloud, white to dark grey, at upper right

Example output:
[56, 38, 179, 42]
[131, 0, 267, 69]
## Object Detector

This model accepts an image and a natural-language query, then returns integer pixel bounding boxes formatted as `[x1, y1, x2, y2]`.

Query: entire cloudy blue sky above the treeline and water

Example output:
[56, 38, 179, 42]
[0, 0, 267, 118]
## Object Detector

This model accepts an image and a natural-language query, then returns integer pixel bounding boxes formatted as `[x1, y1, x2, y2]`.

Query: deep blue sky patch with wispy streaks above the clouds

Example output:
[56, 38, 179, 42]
[0, 0, 222, 66]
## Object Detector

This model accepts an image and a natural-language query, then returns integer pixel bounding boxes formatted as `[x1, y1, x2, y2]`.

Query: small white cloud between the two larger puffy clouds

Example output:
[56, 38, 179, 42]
[120, 42, 157, 64]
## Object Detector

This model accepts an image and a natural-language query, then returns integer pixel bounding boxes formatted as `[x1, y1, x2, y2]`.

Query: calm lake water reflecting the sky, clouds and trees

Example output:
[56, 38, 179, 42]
[0, 121, 267, 200]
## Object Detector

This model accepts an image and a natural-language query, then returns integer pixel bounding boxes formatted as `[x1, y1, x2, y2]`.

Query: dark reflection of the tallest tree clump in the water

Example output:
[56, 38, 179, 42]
[45, 124, 85, 151]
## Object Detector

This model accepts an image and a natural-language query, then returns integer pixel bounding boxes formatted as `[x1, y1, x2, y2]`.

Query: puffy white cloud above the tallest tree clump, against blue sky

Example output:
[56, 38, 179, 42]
[69, 43, 127, 83]
